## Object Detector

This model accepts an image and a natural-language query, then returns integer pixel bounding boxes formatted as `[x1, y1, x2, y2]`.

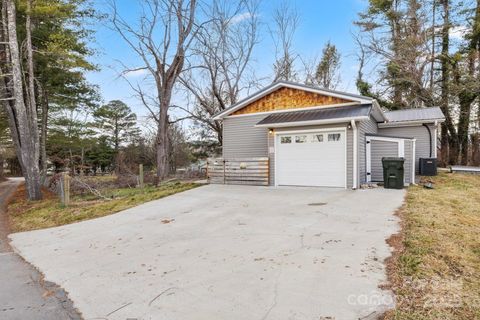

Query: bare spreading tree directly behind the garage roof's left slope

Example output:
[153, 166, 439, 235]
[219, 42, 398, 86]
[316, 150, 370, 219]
[177, 0, 258, 144]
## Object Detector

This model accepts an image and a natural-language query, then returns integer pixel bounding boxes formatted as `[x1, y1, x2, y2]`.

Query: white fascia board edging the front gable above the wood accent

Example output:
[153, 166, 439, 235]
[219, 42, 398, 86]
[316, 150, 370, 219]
[212, 82, 375, 120]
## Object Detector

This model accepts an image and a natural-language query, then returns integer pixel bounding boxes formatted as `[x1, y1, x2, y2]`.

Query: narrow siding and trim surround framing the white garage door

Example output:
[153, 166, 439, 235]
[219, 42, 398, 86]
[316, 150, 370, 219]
[268, 123, 353, 188]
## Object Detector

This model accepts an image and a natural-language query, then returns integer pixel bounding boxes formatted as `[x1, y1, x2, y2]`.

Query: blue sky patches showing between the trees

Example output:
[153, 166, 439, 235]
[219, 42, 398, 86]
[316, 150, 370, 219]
[88, 0, 367, 122]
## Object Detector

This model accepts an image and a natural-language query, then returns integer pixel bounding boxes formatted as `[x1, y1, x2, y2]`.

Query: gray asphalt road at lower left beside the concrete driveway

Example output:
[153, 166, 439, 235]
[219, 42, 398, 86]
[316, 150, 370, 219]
[0, 179, 82, 320]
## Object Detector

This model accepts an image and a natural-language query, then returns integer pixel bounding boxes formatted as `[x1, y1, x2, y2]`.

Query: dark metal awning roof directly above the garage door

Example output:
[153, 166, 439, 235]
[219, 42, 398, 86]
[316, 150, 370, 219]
[257, 104, 372, 126]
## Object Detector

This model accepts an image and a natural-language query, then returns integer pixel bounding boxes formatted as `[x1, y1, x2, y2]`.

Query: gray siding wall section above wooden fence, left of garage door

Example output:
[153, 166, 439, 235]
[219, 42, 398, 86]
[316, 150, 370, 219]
[223, 114, 268, 159]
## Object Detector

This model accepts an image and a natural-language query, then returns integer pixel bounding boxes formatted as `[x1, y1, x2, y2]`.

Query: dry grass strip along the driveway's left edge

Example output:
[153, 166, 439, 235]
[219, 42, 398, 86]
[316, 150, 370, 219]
[8, 182, 199, 232]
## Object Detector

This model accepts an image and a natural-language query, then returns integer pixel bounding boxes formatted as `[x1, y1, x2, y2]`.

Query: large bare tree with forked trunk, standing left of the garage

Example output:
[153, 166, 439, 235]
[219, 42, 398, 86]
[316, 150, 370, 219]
[111, 0, 200, 180]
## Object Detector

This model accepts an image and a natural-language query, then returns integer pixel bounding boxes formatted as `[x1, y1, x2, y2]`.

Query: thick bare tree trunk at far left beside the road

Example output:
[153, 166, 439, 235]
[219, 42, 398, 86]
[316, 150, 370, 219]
[0, 0, 42, 200]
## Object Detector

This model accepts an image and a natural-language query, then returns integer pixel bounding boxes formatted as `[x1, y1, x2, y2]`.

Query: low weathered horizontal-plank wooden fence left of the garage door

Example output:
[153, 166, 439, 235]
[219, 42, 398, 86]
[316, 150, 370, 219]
[207, 158, 270, 186]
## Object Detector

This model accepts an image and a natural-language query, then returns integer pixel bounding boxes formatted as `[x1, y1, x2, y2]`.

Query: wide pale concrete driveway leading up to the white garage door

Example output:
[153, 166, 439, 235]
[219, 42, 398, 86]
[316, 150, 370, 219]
[11, 185, 404, 320]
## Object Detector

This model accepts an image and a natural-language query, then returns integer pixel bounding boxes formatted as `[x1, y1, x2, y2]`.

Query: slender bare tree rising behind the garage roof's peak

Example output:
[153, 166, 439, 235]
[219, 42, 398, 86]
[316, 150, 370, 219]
[270, 1, 300, 81]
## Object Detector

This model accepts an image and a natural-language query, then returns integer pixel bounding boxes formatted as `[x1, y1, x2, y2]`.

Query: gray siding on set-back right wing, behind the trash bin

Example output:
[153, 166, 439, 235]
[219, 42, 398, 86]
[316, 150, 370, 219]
[378, 124, 436, 174]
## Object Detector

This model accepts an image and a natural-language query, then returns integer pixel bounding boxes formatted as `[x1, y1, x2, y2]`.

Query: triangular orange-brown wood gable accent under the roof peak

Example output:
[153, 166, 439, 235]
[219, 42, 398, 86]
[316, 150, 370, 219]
[232, 87, 353, 115]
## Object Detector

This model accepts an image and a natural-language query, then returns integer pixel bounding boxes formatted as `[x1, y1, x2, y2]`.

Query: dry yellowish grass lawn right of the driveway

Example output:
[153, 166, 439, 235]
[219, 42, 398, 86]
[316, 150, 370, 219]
[385, 173, 480, 320]
